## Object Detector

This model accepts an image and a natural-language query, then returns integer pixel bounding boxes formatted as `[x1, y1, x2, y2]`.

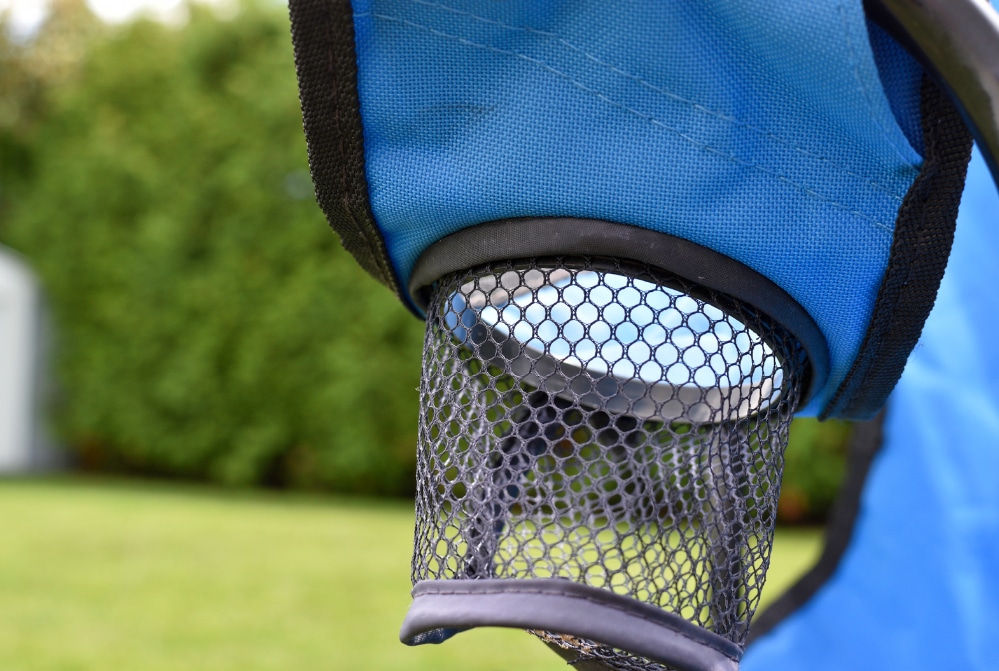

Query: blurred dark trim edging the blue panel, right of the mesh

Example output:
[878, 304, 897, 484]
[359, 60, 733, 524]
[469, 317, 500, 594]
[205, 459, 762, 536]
[746, 411, 885, 646]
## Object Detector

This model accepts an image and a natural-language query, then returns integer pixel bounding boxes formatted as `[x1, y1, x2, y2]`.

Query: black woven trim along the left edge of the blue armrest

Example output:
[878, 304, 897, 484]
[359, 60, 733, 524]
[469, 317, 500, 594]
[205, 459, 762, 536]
[288, 0, 402, 298]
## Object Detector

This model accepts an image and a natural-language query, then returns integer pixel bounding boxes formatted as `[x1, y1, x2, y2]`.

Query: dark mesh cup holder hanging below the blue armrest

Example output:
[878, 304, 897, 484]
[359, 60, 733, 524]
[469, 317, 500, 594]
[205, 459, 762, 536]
[403, 258, 807, 670]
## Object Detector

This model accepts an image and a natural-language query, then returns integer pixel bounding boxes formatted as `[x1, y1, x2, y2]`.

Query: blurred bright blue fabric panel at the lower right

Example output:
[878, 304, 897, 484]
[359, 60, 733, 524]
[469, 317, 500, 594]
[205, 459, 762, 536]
[742, 146, 999, 671]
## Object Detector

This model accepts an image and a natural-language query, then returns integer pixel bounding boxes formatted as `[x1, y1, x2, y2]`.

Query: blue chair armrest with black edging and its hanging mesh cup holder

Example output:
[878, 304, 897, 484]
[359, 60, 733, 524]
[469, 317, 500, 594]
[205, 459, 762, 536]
[291, 0, 999, 671]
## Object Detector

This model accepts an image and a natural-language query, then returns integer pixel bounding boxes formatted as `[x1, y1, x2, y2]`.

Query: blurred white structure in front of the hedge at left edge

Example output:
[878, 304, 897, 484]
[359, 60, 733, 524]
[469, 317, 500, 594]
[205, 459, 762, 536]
[0, 246, 51, 474]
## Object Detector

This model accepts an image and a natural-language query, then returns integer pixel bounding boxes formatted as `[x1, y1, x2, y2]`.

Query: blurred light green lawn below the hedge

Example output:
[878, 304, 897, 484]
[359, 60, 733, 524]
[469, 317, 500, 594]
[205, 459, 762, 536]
[0, 479, 821, 671]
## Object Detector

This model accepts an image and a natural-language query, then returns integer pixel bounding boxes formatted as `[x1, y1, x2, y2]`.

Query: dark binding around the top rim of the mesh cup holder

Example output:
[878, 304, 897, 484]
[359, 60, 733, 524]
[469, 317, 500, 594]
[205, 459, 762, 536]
[409, 217, 829, 405]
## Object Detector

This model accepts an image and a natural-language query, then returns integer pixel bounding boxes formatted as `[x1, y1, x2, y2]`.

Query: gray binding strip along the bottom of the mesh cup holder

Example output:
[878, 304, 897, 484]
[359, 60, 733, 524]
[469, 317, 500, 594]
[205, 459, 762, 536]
[399, 579, 742, 671]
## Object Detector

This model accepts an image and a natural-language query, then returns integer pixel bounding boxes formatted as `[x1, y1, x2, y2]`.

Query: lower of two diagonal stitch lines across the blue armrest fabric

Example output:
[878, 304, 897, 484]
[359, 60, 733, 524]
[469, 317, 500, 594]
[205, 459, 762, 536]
[364, 12, 892, 234]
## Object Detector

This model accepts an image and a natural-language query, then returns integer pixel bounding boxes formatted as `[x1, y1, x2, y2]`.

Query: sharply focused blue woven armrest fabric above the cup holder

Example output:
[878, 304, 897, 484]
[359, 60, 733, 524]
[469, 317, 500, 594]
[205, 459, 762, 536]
[354, 0, 921, 414]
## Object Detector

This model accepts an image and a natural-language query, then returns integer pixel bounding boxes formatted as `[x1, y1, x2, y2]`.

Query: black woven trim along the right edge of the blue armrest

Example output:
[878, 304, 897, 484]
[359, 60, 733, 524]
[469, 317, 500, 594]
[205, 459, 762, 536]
[821, 77, 971, 419]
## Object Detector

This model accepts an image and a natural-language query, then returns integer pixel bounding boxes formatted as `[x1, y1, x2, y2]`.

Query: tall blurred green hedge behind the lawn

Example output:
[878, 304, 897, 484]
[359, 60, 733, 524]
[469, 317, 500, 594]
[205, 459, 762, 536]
[0, 0, 847, 521]
